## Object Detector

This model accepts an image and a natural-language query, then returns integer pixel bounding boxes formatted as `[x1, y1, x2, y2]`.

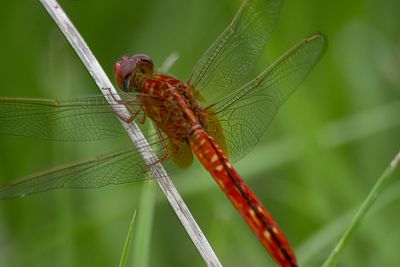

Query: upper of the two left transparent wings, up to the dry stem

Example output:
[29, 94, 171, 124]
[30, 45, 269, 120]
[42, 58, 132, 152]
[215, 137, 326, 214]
[0, 95, 142, 141]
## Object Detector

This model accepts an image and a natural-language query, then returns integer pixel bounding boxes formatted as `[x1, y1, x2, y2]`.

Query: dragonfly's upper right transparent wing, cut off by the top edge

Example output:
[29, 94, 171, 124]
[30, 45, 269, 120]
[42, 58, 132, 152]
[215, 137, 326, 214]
[189, 0, 282, 104]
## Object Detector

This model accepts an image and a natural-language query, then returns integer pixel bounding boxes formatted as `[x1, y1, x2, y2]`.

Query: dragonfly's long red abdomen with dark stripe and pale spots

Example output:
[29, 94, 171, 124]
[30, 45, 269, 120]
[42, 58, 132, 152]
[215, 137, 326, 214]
[189, 128, 297, 267]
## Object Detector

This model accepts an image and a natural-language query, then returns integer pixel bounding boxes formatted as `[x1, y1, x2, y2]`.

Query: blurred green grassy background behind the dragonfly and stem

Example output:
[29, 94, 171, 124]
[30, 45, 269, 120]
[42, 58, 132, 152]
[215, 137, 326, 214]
[0, 0, 400, 266]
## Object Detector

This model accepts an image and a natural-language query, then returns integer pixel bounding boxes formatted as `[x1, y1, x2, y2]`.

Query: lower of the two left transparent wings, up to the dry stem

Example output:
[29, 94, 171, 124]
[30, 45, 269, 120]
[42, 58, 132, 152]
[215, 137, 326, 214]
[0, 149, 150, 199]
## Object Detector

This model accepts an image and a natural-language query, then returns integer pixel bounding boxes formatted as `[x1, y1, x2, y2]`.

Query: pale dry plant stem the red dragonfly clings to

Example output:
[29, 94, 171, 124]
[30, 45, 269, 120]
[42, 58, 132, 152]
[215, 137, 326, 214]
[40, 0, 222, 266]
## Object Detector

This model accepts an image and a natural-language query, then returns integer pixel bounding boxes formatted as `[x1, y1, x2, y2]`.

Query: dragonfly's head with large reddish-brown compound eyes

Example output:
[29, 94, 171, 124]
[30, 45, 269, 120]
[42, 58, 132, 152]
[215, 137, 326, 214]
[114, 54, 154, 92]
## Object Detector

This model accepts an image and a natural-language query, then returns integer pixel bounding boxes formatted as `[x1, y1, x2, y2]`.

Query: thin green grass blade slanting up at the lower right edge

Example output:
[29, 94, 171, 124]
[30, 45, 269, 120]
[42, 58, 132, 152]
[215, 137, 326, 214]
[323, 153, 400, 267]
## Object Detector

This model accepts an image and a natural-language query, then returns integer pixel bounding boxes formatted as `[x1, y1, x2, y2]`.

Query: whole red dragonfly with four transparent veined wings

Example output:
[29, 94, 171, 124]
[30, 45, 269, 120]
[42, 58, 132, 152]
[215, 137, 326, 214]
[0, 0, 326, 266]
